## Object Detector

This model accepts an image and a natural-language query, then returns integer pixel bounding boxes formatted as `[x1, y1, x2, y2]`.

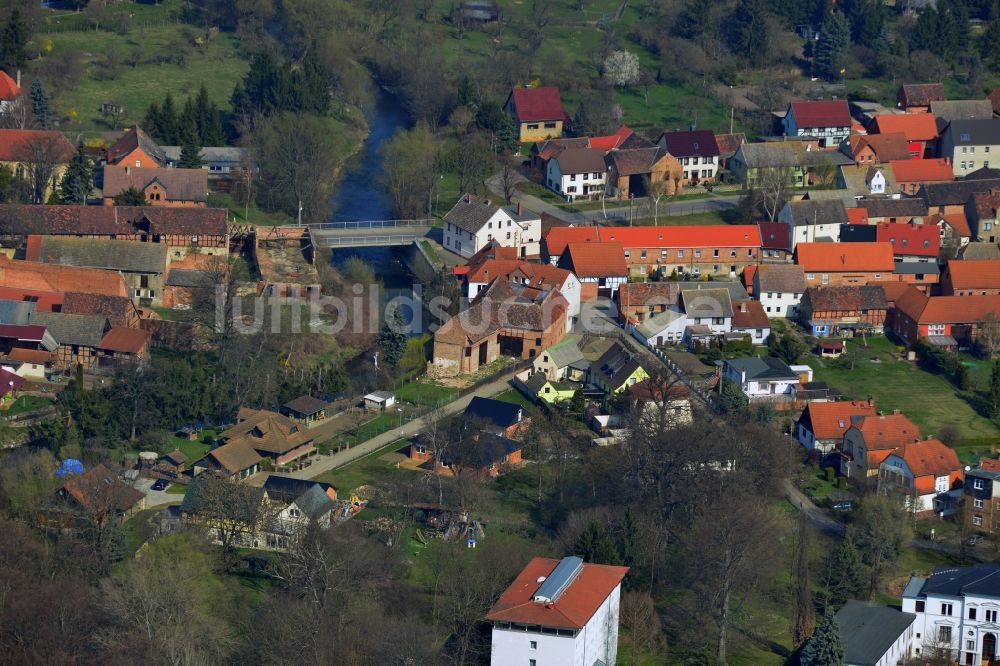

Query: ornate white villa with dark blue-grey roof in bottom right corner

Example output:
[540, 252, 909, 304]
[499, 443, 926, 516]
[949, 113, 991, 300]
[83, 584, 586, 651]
[903, 563, 1000, 666]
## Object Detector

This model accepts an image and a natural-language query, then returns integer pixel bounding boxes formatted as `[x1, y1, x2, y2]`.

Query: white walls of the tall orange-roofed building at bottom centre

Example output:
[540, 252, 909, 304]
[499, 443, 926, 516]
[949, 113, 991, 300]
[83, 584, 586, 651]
[490, 585, 621, 666]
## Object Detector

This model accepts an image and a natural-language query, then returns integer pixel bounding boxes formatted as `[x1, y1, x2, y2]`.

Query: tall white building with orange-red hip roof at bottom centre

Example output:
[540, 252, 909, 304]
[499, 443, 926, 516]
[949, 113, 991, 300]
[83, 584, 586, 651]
[486, 557, 628, 666]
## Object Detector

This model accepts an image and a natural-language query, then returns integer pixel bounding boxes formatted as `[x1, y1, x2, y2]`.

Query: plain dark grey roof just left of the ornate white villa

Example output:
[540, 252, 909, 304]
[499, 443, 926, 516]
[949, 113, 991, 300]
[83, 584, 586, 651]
[836, 600, 917, 666]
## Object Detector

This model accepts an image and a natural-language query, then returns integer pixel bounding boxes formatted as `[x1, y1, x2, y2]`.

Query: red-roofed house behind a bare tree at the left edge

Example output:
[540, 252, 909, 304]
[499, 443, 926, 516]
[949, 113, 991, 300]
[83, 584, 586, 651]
[0, 129, 76, 203]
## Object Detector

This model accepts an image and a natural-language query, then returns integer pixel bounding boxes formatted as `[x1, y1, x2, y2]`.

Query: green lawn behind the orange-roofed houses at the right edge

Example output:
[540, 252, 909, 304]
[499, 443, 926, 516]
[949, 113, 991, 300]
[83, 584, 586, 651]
[805, 336, 1000, 443]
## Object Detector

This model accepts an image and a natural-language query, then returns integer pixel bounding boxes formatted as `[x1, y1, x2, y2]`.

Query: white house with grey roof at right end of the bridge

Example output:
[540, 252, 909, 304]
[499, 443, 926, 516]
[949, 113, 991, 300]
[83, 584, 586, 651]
[444, 194, 542, 257]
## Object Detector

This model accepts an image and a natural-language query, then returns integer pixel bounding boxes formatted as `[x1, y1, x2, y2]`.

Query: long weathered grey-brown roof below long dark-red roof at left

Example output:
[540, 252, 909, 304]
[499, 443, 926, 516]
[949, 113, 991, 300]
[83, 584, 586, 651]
[38, 236, 167, 273]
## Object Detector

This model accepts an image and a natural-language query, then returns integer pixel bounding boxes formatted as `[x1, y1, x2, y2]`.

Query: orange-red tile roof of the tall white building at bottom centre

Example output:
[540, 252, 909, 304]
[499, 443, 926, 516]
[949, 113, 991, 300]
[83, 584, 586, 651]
[486, 557, 628, 629]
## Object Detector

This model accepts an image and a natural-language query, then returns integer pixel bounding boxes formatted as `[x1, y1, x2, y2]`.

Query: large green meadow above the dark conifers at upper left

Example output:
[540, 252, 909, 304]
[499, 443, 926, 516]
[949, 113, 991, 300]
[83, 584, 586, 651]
[37, 22, 249, 131]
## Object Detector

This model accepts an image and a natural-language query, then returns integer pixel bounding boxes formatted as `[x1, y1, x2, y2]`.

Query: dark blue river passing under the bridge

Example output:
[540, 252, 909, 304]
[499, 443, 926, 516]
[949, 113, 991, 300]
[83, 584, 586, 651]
[331, 88, 416, 326]
